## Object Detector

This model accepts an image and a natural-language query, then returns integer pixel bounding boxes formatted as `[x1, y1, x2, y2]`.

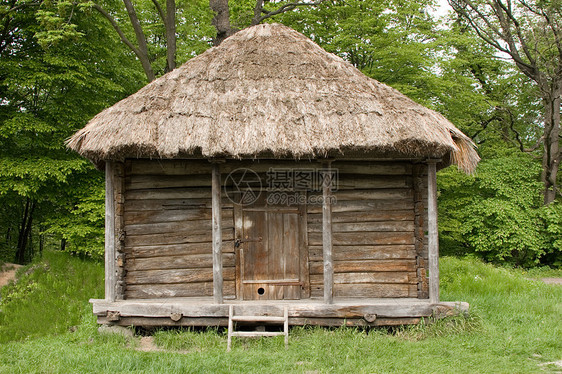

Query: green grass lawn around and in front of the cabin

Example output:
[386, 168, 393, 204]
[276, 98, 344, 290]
[0, 253, 562, 373]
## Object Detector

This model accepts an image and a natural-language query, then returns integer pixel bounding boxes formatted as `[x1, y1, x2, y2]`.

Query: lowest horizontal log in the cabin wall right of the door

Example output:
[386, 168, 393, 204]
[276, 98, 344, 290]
[334, 283, 418, 297]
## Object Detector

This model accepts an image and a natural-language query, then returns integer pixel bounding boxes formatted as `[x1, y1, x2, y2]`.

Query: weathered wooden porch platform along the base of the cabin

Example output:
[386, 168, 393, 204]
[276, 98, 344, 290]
[90, 297, 469, 326]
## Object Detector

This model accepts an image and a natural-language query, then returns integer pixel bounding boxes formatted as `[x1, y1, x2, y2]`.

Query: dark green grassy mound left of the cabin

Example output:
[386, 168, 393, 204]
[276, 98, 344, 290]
[0, 251, 104, 344]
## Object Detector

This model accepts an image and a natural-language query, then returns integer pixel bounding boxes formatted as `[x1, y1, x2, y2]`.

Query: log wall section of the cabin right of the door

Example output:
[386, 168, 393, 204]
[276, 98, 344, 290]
[307, 161, 423, 298]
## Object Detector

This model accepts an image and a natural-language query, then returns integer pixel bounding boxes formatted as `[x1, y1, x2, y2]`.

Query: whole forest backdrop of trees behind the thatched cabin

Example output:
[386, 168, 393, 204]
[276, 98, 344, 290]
[0, 0, 562, 268]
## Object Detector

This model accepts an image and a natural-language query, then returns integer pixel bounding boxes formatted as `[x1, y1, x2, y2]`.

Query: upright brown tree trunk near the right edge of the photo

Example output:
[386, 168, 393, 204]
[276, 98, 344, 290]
[541, 83, 561, 205]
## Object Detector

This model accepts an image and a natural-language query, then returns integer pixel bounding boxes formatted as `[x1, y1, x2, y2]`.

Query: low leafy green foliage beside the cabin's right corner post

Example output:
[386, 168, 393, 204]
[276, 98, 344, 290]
[438, 150, 562, 266]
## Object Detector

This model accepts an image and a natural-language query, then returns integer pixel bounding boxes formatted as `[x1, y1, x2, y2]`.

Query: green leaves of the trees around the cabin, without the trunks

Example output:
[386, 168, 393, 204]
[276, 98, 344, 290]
[0, 0, 562, 266]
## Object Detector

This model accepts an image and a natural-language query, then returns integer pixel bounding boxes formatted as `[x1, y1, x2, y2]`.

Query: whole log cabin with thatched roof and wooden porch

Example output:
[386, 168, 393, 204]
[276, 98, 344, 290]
[68, 24, 479, 326]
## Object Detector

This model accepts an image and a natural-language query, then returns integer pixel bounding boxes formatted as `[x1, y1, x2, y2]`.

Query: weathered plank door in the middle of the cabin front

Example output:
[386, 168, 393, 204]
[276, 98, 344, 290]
[236, 199, 310, 300]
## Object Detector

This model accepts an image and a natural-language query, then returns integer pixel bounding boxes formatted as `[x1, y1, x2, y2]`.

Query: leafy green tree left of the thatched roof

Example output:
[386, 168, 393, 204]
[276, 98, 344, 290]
[0, 0, 144, 263]
